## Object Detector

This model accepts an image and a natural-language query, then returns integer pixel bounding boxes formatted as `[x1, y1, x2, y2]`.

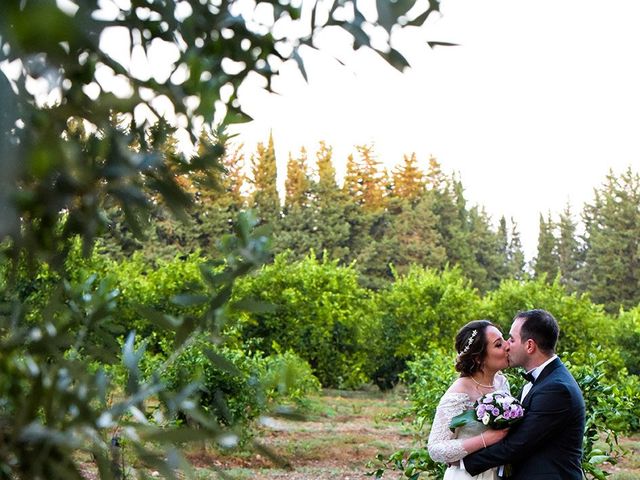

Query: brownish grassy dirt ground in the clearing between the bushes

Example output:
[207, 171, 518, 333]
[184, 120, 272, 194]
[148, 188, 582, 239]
[85, 391, 640, 480]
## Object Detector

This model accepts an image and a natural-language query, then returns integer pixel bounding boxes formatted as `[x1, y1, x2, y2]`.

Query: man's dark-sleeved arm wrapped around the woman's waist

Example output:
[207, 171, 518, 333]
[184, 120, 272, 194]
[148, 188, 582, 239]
[464, 383, 575, 475]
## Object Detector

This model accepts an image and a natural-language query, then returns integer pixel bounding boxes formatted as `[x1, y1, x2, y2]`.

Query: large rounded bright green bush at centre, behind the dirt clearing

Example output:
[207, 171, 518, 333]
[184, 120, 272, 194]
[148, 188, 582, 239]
[233, 254, 378, 388]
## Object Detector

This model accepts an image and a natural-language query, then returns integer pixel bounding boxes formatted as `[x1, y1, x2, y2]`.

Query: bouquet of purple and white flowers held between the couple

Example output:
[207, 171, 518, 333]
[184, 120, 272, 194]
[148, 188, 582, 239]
[449, 392, 524, 431]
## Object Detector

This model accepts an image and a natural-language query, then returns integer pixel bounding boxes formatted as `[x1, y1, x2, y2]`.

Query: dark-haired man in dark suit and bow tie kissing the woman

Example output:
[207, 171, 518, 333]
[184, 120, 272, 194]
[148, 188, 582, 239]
[463, 310, 585, 480]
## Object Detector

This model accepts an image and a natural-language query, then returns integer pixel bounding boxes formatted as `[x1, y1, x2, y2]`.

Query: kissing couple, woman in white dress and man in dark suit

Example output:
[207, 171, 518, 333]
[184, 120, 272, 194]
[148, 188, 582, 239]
[427, 309, 585, 480]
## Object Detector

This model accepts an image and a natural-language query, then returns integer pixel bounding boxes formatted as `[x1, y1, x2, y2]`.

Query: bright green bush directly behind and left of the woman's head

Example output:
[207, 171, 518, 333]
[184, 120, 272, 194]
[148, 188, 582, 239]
[374, 266, 480, 389]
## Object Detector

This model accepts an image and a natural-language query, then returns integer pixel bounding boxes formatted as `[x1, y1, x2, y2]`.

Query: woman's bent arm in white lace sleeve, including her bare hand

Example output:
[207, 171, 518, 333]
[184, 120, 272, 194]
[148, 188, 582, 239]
[427, 393, 506, 463]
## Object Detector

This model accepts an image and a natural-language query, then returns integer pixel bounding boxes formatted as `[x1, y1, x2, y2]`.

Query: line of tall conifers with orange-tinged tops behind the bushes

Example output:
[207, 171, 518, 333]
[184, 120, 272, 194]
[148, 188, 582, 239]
[103, 131, 640, 311]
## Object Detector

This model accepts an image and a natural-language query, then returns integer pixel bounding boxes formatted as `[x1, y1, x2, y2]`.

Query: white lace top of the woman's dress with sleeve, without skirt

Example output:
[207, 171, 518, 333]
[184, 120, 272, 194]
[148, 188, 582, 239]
[427, 376, 509, 463]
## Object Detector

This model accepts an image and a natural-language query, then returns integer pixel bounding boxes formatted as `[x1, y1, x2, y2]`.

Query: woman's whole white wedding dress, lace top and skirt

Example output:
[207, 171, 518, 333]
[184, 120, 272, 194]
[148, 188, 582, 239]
[427, 375, 509, 480]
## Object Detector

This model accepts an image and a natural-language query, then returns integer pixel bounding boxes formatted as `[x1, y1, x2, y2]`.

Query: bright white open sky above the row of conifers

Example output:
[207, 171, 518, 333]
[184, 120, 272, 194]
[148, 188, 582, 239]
[232, 0, 640, 258]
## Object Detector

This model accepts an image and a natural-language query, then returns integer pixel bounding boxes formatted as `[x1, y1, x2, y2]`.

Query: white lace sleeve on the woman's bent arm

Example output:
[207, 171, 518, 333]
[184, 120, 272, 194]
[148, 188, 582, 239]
[427, 393, 469, 463]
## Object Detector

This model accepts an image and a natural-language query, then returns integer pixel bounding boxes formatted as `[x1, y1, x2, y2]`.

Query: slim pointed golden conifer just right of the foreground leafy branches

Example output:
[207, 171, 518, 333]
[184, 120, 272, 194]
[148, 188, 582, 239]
[251, 134, 280, 226]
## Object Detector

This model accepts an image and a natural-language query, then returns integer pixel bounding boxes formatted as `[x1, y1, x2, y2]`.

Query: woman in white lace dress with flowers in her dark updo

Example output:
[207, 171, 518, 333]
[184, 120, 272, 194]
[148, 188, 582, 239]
[427, 320, 509, 480]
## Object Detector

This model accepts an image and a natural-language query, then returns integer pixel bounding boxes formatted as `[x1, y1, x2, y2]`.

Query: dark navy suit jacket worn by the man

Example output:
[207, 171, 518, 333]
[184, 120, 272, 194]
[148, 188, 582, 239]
[463, 358, 585, 480]
